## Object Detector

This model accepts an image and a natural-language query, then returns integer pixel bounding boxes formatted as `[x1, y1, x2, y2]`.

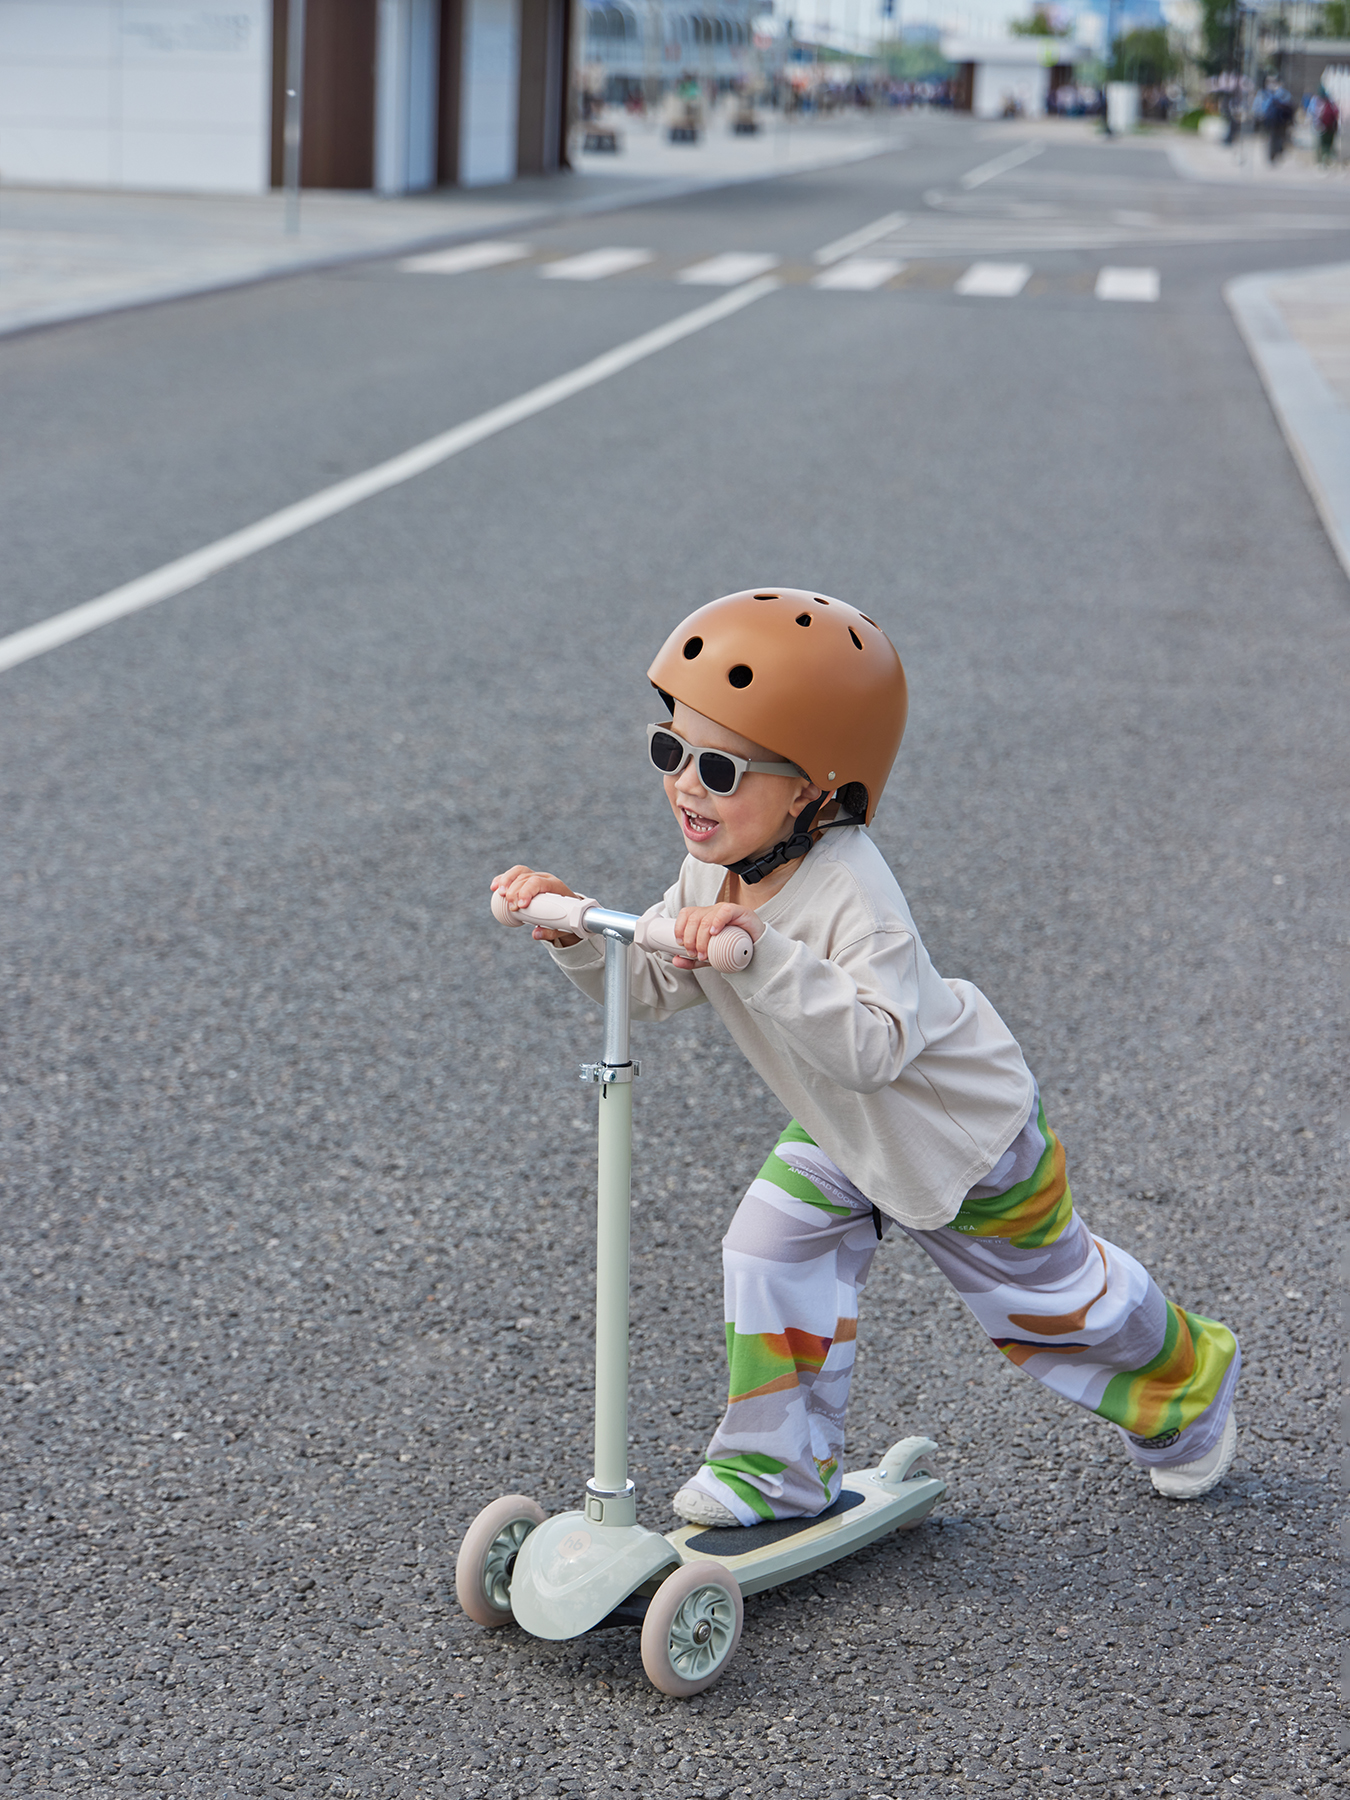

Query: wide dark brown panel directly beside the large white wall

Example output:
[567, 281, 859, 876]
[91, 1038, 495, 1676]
[272, 0, 376, 187]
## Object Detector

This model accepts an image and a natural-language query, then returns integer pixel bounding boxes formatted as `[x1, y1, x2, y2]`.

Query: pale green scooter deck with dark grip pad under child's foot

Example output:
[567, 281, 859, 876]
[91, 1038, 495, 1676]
[666, 1469, 947, 1595]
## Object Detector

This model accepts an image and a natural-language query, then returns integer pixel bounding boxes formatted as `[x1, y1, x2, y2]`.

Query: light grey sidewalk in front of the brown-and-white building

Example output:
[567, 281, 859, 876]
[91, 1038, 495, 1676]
[0, 119, 900, 335]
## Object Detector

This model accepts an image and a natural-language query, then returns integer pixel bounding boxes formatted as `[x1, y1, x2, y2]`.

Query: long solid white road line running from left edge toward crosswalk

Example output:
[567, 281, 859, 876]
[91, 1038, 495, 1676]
[0, 275, 779, 671]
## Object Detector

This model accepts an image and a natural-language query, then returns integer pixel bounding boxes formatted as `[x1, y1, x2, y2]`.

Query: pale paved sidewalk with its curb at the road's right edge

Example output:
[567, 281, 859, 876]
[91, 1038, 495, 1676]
[1224, 263, 1350, 576]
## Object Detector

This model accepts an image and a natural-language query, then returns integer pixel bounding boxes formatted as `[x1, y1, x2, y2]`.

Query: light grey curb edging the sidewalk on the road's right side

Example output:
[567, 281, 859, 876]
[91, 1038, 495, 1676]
[1224, 266, 1350, 576]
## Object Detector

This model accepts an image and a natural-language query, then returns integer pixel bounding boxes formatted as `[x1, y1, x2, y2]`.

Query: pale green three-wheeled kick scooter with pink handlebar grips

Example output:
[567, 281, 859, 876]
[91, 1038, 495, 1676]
[455, 895, 947, 1697]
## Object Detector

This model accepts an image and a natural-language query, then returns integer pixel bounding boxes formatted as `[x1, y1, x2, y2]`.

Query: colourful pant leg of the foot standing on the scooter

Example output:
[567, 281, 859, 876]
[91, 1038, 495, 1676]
[691, 1125, 889, 1525]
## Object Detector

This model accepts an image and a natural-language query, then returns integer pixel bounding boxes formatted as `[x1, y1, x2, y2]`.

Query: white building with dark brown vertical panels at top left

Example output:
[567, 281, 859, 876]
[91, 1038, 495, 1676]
[0, 0, 574, 193]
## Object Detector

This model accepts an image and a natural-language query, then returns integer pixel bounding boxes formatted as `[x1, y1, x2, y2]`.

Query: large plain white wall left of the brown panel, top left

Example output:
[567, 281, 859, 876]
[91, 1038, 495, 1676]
[0, 0, 272, 193]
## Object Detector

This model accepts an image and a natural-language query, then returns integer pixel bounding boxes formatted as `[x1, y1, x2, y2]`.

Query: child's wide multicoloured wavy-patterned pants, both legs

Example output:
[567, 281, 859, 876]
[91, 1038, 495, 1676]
[693, 1098, 1242, 1525]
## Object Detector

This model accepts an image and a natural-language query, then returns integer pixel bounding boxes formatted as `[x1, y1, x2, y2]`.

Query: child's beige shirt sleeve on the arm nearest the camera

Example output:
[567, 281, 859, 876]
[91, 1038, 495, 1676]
[725, 925, 923, 1094]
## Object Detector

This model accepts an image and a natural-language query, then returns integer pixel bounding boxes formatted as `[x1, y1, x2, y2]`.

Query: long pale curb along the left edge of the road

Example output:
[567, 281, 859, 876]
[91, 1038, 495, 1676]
[0, 137, 905, 338]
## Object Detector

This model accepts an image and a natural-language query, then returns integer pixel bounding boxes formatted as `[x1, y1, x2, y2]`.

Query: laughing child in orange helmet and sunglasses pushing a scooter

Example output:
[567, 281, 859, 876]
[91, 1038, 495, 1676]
[493, 589, 1240, 1525]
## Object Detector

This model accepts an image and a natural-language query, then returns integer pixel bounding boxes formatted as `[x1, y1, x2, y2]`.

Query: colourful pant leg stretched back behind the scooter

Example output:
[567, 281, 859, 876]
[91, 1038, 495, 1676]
[905, 1087, 1242, 1469]
